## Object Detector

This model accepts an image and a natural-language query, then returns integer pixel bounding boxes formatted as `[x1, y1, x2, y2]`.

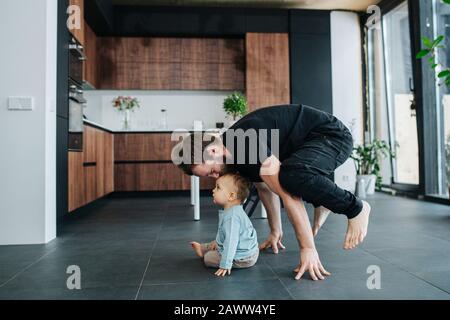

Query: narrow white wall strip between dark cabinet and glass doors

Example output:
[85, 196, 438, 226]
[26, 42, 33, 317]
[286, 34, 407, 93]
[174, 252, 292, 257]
[331, 11, 363, 191]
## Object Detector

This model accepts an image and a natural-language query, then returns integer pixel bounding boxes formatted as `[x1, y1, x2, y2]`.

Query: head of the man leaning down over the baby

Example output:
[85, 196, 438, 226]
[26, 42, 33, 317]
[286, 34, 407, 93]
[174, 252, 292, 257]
[178, 133, 226, 179]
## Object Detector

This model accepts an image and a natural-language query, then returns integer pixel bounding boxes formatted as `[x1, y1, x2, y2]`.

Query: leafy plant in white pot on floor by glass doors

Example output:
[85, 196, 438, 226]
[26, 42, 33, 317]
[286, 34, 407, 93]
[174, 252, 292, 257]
[350, 140, 395, 194]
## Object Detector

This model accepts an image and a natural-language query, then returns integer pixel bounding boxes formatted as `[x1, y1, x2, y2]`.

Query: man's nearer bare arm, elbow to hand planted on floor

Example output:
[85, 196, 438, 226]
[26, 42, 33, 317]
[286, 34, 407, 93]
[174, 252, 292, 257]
[260, 156, 329, 280]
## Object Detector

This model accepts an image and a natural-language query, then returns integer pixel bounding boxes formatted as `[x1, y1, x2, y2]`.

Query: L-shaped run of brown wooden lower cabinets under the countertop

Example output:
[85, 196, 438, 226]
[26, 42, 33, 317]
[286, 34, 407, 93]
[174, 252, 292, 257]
[68, 125, 215, 212]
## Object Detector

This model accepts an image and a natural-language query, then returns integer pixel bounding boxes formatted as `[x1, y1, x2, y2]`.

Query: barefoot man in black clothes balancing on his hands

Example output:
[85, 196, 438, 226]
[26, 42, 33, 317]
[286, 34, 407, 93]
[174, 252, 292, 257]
[179, 104, 370, 280]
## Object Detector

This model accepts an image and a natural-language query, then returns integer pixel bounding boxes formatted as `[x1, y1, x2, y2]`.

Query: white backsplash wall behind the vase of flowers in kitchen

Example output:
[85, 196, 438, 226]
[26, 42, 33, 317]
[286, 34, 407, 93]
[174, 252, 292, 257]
[84, 90, 231, 130]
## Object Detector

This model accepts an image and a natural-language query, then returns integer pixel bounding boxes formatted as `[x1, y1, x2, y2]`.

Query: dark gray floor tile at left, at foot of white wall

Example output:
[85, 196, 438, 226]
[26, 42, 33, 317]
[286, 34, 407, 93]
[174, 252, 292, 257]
[1, 240, 154, 290]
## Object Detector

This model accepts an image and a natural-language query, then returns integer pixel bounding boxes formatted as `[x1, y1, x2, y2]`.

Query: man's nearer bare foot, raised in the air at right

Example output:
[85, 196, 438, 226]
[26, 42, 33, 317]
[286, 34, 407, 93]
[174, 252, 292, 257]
[344, 200, 371, 250]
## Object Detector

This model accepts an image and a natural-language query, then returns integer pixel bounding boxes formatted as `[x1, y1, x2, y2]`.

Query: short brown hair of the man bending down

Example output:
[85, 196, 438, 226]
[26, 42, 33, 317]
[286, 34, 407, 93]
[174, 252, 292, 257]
[178, 132, 217, 176]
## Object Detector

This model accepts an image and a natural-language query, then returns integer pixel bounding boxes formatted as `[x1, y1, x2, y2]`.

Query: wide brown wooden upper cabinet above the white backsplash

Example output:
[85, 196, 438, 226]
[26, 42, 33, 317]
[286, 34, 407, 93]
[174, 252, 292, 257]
[96, 37, 245, 90]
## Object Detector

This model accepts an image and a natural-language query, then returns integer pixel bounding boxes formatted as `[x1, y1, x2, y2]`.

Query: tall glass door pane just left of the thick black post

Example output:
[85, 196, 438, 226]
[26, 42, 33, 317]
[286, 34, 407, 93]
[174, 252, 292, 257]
[382, 1, 419, 185]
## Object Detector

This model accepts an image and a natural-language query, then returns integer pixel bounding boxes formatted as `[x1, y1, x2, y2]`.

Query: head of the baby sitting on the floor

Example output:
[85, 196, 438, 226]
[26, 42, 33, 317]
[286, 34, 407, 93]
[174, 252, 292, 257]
[213, 173, 251, 208]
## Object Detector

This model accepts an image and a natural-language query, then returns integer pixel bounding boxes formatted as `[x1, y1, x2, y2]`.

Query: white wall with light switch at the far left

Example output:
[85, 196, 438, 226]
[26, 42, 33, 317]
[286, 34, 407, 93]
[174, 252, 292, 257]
[0, 0, 57, 245]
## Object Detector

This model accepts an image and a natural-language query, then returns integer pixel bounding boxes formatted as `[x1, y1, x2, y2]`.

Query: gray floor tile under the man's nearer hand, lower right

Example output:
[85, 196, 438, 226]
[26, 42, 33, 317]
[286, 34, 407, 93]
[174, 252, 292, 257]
[272, 250, 450, 300]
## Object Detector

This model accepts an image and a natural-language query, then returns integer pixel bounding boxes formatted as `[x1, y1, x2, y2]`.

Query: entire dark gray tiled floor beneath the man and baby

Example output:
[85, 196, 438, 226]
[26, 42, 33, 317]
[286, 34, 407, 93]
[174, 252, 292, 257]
[0, 194, 450, 300]
